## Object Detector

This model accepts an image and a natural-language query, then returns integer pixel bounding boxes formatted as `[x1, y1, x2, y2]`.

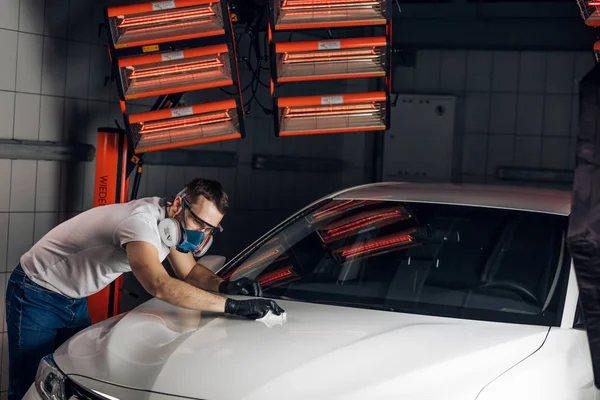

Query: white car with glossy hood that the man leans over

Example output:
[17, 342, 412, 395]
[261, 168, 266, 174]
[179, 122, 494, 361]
[26, 183, 599, 400]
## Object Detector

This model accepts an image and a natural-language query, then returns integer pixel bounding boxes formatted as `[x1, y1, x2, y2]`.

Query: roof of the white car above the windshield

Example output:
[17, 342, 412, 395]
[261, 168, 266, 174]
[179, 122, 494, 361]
[331, 182, 571, 215]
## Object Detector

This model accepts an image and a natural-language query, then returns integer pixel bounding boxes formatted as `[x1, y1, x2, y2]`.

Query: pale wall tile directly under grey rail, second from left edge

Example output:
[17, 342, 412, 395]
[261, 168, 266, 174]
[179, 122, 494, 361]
[10, 160, 37, 212]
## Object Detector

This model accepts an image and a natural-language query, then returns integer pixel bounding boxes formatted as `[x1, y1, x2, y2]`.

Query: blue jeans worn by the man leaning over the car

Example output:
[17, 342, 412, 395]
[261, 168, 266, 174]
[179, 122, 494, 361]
[6, 264, 90, 400]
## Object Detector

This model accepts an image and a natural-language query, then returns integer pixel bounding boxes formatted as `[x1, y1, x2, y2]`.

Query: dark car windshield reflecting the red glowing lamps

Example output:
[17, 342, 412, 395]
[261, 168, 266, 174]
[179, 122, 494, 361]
[220, 200, 570, 325]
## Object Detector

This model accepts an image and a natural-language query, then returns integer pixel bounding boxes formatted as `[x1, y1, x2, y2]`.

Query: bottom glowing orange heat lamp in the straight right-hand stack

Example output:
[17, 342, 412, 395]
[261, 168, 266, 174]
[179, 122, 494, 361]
[274, 92, 390, 136]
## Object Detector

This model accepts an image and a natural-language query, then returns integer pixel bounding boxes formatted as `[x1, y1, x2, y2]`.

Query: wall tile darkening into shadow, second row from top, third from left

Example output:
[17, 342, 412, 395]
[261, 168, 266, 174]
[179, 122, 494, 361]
[42, 37, 67, 96]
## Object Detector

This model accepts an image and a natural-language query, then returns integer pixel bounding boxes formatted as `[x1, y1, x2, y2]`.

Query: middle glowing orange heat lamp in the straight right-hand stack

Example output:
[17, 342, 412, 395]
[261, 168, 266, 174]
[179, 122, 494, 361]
[271, 36, 390, 83]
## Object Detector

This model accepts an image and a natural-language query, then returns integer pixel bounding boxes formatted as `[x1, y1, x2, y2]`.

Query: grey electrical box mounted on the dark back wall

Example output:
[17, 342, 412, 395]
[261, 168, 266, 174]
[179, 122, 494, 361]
[382, 94, 456, 182]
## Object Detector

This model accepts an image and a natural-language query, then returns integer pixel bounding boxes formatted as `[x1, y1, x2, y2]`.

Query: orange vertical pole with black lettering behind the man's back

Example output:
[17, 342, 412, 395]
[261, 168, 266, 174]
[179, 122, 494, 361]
[87, 128, 128, 324]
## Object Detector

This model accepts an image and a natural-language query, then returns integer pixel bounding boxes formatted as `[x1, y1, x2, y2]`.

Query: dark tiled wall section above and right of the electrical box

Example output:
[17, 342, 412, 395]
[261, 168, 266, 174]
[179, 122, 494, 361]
[392, 50, 594, 189]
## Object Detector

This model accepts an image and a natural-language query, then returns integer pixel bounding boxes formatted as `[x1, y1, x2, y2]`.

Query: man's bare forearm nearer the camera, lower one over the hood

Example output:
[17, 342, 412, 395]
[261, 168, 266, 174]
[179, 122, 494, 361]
[154, 277, 227, 312]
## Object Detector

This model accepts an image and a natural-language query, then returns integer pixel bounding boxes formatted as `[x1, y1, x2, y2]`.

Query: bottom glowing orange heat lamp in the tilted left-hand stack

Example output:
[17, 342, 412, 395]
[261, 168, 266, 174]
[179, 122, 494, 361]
[125, 98, 245, 154]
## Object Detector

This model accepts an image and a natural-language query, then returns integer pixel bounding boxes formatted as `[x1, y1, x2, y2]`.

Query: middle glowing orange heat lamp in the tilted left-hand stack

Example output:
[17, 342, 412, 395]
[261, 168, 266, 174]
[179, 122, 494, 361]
[116, 44, 237, 101]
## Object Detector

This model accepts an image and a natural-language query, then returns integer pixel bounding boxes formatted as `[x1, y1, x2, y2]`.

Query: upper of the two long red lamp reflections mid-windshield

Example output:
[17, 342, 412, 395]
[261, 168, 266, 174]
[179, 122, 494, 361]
[321, 207, 411, 243]
